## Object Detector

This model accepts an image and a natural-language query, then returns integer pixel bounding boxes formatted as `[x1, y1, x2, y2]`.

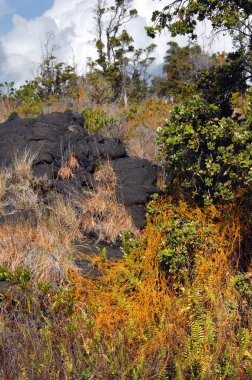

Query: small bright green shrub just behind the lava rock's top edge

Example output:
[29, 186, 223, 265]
[82, 108, 115, 133]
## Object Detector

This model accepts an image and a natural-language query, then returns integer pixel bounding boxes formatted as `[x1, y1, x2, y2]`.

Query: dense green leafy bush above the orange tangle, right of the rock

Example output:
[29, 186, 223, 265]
[157, 96, 252, 204]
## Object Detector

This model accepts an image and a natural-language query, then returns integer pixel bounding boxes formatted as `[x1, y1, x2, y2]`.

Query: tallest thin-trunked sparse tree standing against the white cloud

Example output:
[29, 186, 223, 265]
[89, 0, 137, 106]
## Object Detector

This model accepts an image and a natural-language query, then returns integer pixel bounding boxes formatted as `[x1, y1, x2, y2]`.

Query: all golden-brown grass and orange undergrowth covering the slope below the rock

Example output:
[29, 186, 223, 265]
[0, 150, 252, 380]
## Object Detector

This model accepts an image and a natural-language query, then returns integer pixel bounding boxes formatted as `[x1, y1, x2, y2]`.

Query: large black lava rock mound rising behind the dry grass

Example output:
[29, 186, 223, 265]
[0, 111, 158, 227]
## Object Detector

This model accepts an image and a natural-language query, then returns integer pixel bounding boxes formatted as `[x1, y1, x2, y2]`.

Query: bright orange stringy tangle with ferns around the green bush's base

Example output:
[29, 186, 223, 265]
[69, 199, 251, 379]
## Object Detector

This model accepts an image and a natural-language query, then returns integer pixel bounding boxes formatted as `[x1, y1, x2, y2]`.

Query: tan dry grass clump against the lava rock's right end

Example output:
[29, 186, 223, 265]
[81, 161, 138, 243]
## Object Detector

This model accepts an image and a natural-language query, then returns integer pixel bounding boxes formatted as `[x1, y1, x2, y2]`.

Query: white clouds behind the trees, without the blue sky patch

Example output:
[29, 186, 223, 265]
[0, 0, 232, 85]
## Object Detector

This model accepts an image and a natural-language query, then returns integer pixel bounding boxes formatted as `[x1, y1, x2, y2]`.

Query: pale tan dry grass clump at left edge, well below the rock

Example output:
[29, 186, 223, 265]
[0, 223, 73, 284]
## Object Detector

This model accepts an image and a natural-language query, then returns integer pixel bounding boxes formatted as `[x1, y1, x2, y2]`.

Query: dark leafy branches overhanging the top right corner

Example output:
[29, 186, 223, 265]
[147, 0, 252, 79]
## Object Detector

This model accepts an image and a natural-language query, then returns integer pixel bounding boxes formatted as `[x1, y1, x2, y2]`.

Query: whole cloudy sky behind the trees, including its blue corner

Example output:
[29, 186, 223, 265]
[0, 0, 231, 85]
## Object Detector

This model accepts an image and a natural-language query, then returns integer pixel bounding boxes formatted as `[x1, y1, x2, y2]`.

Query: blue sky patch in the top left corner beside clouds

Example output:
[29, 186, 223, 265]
[0, 0, 53, 34]
